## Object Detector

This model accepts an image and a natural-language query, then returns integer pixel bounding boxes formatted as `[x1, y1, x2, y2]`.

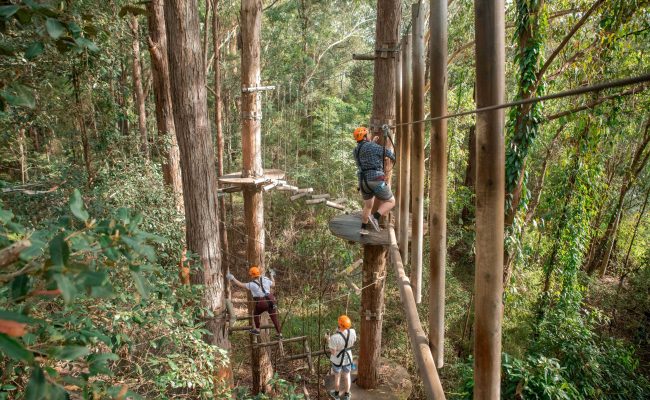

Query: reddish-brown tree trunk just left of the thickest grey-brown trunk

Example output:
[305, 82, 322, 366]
[147, 0, 183, 212]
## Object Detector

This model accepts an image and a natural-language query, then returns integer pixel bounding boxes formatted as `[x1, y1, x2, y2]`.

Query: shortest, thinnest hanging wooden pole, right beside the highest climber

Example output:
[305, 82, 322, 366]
[399, 35, 413, 260]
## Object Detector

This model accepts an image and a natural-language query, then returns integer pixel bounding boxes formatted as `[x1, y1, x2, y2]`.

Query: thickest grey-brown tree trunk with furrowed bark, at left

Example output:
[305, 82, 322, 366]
[165, 0, 230, 370]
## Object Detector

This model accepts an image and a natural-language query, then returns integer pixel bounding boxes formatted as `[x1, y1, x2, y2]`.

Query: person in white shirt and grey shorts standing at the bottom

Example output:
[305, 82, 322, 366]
[329, 315, 357, 400]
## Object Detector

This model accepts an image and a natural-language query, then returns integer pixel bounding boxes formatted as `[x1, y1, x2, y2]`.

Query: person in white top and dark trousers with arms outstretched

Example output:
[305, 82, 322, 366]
[226, 265, 282, 338]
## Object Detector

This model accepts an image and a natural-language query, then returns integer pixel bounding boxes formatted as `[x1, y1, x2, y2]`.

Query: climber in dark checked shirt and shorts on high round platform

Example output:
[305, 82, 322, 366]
[354, 126, 395, 235]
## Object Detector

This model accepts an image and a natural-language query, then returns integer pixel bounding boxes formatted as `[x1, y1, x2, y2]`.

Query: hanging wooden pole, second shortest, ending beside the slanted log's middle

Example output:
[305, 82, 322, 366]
[411, 3, 425, 304]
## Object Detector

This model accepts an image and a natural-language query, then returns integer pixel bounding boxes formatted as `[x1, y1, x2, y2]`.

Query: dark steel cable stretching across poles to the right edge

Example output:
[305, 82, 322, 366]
[391, 73, 650, 128]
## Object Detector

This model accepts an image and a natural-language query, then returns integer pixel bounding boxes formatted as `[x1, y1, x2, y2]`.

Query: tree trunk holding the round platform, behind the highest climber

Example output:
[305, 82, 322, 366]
[357, 0, 401, 389]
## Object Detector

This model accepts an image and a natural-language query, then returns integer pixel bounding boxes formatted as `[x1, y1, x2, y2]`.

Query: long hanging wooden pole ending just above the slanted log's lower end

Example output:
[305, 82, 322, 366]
[429, 0, 447, 368]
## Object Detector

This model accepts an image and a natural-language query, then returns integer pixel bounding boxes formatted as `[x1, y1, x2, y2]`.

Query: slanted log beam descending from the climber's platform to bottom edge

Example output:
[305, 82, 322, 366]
[389, 227, 445, 399]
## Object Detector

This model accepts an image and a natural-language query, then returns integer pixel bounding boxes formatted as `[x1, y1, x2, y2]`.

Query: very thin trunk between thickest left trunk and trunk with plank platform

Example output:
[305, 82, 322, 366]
[212, 0, 230, 293]
